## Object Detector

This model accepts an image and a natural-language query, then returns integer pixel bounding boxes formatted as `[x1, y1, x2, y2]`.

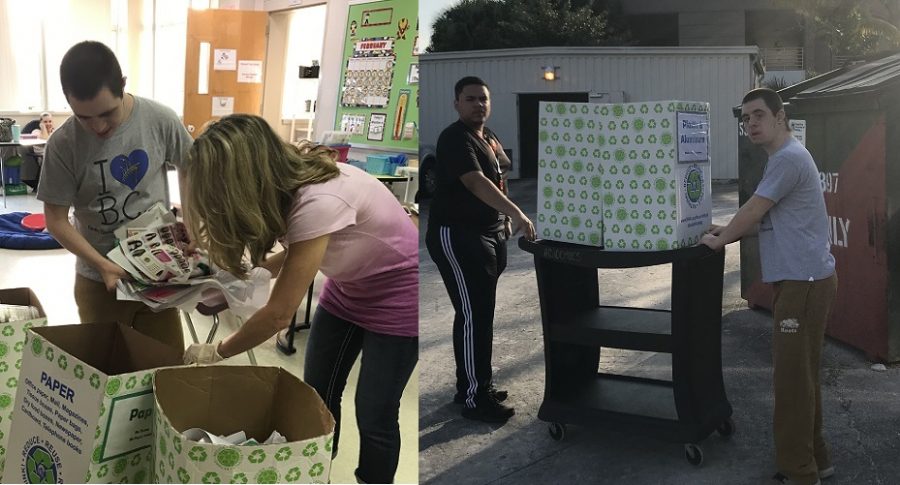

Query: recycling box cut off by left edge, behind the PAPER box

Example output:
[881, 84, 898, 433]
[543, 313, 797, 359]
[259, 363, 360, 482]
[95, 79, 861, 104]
[0, 288, 47, 476]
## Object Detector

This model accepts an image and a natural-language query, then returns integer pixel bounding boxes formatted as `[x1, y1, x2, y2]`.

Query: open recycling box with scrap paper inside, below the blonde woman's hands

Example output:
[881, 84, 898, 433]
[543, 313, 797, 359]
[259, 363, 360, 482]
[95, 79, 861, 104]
[153, 366, 334, 483]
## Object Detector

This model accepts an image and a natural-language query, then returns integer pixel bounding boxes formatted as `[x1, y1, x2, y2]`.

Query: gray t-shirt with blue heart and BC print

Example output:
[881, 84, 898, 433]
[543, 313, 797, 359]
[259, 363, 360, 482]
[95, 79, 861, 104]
[37, 96, 193, 281]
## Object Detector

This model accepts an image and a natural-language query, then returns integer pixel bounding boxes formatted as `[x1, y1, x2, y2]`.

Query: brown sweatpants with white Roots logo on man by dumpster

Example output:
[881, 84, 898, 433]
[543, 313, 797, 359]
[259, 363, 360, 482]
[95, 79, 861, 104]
[773, 275, 837, 484]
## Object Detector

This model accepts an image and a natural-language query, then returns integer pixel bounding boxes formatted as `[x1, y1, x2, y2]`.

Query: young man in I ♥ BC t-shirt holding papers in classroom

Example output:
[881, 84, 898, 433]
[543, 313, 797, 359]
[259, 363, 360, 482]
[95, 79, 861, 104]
[38, 41, 192, 350]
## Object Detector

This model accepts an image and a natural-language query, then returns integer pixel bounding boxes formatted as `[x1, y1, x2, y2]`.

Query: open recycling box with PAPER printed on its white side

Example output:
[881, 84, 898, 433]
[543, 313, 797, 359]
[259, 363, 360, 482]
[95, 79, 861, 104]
[3, 323, 182, 483]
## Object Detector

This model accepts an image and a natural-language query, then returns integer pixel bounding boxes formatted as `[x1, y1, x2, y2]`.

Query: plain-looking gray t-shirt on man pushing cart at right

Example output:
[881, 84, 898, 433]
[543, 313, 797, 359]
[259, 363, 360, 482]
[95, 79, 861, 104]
[756, 137, 834, 283]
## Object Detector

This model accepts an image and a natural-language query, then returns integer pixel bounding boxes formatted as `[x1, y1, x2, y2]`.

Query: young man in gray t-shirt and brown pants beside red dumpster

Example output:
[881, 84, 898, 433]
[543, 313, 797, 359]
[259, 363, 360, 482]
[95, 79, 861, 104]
[700, 88, 837, 485]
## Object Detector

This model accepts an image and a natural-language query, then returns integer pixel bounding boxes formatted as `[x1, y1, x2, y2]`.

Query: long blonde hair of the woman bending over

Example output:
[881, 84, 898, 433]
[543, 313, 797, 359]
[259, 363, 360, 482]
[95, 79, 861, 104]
[187, 114, 340, 278]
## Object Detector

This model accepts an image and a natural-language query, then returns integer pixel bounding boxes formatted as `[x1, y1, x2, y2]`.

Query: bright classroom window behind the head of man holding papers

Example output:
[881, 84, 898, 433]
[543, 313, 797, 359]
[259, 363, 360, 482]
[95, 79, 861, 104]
[0, 0, 191, 114]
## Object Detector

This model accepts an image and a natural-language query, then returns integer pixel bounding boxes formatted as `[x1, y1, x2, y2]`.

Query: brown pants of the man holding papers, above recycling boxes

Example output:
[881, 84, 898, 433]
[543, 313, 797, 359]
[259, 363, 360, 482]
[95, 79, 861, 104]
[75, 275, 184, 350]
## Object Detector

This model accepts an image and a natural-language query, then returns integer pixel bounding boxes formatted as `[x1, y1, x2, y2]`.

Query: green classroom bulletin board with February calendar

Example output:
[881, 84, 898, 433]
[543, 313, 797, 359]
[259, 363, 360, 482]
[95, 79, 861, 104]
[334, 0, 420, 151]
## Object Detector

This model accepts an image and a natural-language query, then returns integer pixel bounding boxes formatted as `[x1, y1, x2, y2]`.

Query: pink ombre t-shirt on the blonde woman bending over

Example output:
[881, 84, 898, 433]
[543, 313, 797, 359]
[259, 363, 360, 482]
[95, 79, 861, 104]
[284, 163, 419, 337]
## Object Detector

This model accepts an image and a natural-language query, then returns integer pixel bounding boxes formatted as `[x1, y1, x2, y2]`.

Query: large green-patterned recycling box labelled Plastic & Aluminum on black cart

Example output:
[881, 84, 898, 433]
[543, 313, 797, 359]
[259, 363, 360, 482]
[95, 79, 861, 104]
[537, 101, 712, 251]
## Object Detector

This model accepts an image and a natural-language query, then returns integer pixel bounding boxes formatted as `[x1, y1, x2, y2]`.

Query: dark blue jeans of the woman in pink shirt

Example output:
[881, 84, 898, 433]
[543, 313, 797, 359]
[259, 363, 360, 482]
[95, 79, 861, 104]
[303, 307, 419, 483]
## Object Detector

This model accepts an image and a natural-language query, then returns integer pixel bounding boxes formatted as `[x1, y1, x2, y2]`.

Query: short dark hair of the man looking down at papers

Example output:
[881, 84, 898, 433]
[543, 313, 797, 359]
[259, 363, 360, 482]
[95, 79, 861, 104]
[59, 40, 125, 101]
